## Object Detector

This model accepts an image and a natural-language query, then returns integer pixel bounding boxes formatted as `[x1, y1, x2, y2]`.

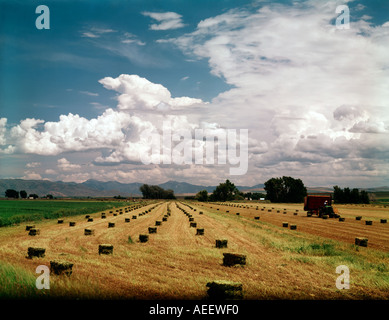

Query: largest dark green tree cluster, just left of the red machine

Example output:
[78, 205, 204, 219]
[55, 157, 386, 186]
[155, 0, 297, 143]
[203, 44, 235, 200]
[264, 176, 307, 203]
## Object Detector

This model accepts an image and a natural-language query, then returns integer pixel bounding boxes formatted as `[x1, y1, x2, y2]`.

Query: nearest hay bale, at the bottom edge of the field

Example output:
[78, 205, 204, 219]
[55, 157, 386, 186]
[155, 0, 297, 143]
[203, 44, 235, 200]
[206, 280, 243, 300]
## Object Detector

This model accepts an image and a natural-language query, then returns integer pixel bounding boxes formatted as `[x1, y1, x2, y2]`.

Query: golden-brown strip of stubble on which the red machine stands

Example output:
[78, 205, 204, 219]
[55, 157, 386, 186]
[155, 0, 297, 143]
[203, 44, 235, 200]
[197, 204, 389, 252]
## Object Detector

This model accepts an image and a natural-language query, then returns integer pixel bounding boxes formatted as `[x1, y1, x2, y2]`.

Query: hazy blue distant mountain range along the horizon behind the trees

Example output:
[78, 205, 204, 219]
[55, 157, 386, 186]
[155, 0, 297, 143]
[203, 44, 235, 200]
[0, 179, 389, 197]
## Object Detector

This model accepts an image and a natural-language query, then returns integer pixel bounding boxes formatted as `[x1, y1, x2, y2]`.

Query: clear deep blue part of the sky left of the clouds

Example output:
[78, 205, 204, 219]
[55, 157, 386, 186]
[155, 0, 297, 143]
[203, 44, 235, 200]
[1, 1, 239, 121]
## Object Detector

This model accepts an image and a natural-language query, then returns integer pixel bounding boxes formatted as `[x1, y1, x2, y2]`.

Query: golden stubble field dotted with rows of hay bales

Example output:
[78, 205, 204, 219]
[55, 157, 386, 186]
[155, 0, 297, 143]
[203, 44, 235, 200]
[0, 201, 389, 300]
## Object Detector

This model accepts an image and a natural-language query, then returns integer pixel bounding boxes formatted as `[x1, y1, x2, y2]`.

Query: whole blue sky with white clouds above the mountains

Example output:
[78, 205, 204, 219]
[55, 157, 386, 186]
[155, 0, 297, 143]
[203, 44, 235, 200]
[0, 0, 389, 187]
